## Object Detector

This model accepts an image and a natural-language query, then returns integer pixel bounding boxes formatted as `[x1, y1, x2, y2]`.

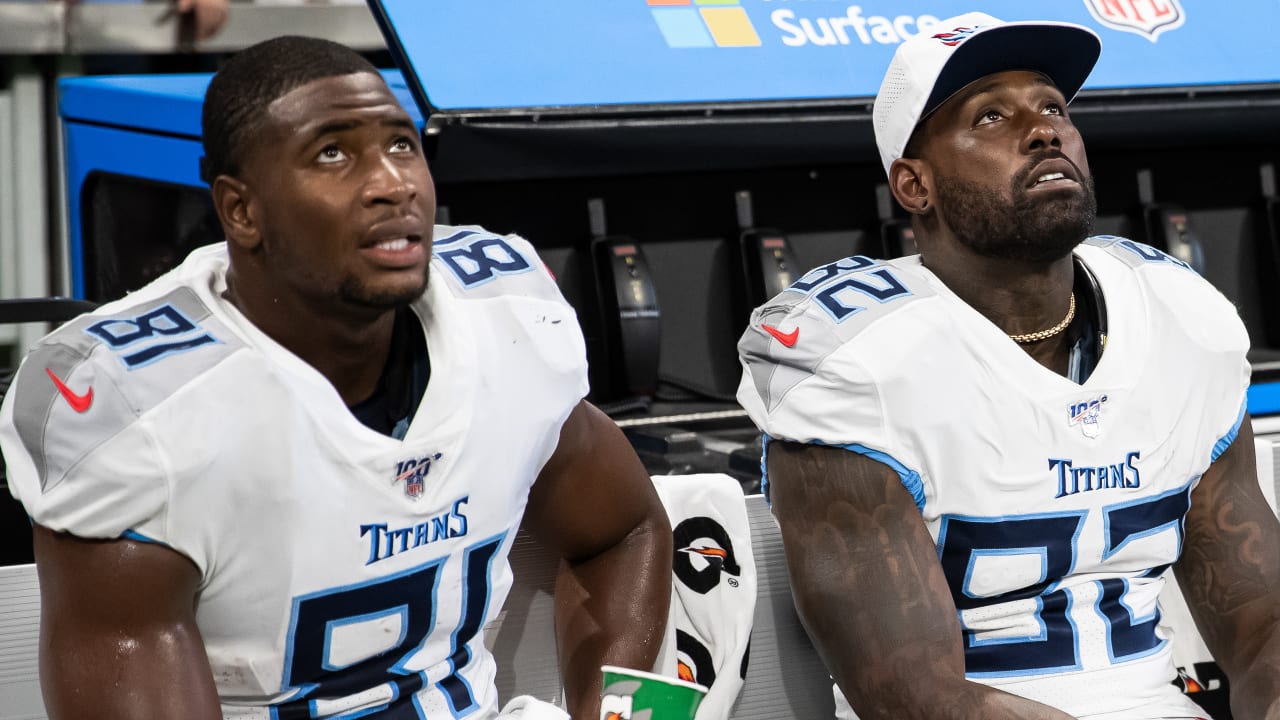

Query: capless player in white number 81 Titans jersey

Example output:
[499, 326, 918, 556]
[0, 37, 672, 720]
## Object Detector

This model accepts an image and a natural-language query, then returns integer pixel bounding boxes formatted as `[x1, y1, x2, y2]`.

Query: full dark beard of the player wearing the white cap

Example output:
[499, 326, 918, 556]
[937, 155, 1098, 263]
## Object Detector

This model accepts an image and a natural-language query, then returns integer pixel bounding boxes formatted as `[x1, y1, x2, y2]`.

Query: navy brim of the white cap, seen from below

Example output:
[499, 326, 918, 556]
[920, 23, 1102, 120]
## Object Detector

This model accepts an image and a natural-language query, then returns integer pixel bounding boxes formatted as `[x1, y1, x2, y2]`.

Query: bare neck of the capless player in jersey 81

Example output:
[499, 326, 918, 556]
[223, 270, 396, 405]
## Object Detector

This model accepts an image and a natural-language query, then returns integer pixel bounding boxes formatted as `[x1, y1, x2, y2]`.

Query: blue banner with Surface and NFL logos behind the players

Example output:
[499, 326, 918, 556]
[370, 0, 1280, 110]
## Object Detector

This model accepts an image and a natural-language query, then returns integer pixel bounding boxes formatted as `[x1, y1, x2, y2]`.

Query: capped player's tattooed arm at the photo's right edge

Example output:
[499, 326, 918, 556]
[1174, 415, 1280, 720]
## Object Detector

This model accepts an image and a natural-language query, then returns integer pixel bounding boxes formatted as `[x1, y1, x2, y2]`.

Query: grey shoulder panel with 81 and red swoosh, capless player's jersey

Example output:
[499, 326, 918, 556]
[9, 287, 243, 489]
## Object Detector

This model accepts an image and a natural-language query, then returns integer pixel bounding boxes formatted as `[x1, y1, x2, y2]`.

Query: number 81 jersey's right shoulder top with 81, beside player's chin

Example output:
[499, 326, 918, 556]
[431, 225, 561, 300]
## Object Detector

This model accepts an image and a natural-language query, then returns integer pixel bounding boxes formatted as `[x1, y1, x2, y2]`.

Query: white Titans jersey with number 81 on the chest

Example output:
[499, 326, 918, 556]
[0, 227, 588, 719]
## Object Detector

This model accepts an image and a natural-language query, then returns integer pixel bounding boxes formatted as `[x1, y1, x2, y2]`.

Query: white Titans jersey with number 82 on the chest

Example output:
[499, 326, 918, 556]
[739, 237, 1249, 719]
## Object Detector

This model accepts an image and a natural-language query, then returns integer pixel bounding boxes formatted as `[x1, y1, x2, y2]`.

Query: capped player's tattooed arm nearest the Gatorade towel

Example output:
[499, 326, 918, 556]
[768, 442, 1070, 720]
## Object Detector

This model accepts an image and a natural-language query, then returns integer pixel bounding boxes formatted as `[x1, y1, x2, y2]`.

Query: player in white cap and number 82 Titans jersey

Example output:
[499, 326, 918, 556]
[739, 13, 1280, 720]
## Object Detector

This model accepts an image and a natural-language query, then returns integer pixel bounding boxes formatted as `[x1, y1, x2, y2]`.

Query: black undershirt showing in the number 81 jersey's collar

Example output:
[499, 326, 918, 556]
[348, 307, 431, 439]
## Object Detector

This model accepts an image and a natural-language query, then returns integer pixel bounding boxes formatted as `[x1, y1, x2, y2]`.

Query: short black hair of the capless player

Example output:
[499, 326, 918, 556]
[200, 35, 378, 184]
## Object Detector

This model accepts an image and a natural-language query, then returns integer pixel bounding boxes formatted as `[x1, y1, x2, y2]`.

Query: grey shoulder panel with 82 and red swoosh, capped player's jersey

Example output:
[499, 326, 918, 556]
[739, 255, 937, 370]
